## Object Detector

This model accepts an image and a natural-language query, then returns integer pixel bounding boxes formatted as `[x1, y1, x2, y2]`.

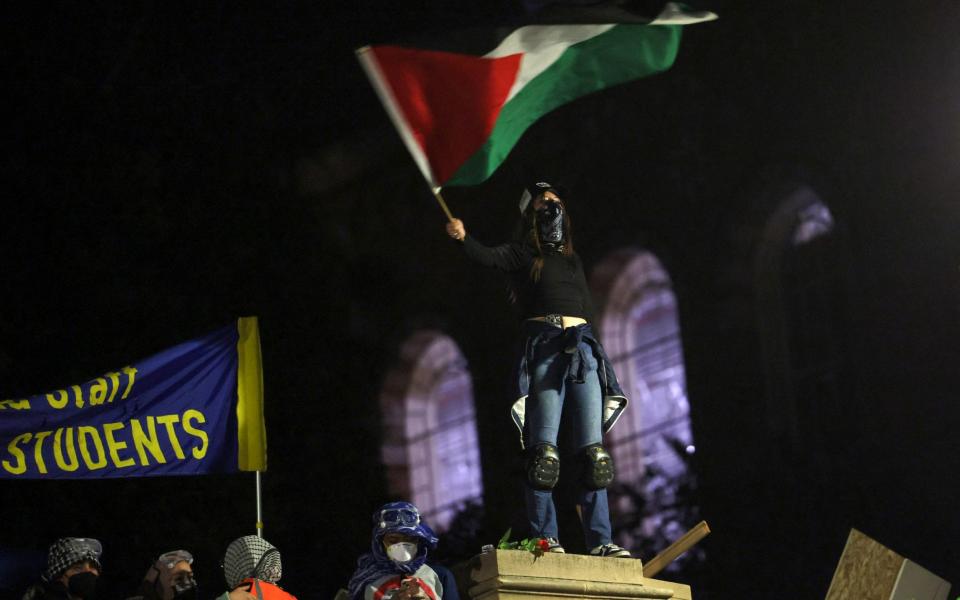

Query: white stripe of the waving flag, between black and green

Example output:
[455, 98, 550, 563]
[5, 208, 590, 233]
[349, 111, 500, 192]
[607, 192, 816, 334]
[484, 2, 717, 103]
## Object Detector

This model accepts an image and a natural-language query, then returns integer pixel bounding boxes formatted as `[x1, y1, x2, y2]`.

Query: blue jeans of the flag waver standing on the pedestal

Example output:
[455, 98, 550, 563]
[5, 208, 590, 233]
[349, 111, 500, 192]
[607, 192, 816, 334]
[525, 338, 612, 549]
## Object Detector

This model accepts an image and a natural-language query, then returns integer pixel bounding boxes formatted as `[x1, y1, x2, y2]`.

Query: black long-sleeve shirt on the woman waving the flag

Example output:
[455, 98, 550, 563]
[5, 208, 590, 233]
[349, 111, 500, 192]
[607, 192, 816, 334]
[463, 234, 593, 322]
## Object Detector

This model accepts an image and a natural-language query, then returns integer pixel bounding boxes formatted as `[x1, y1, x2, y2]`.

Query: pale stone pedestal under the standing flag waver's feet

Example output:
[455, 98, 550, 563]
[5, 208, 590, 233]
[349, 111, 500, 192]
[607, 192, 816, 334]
[469, 550, 693, 600]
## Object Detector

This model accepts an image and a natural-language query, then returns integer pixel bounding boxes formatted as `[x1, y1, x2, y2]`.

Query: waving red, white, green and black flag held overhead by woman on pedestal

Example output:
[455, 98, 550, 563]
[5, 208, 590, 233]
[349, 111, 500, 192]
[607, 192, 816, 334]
[357, 3, 716, 191]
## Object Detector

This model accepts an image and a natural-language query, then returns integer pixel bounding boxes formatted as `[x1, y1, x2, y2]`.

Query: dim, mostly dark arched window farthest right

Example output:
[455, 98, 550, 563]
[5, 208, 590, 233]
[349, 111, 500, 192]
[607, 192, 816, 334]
[754, 185, 846, 452]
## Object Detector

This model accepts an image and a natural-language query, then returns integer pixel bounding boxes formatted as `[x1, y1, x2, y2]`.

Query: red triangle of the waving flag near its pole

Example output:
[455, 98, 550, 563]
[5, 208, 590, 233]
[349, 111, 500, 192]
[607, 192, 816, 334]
[372, 46, 522, 185]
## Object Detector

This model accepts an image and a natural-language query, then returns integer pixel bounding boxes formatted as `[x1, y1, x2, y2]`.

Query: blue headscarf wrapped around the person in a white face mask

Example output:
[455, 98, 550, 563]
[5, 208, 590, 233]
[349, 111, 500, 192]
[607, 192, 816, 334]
[347, 502, 437, 600]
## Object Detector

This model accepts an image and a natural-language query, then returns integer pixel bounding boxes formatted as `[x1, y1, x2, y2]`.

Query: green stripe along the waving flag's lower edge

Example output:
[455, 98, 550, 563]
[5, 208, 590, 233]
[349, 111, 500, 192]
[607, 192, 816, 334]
[444, 25, 681, 185]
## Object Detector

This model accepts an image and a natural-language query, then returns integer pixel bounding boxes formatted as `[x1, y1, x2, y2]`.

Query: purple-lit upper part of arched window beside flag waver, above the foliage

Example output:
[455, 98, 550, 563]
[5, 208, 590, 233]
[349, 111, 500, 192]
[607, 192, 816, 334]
[592, 250, 694, 482]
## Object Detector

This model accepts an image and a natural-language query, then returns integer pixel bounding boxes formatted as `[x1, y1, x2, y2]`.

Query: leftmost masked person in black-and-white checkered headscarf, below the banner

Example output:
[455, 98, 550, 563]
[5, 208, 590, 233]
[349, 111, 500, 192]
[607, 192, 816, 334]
[23, 538, 103, 600]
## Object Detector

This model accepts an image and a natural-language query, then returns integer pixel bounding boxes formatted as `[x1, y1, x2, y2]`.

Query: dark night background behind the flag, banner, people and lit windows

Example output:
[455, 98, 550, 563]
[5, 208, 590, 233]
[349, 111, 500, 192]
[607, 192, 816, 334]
[0, 0, 960, 598]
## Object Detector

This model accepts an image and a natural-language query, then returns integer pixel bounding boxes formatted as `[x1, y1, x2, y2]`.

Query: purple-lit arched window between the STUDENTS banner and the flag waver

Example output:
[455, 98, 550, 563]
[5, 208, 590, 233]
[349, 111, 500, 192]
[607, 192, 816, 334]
[380, 331, 483, 531]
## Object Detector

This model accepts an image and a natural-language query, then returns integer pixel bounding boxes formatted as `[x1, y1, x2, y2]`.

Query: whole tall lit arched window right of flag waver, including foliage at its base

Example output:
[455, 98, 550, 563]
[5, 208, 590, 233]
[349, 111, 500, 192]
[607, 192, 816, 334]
[591, 249, 702, 560]
